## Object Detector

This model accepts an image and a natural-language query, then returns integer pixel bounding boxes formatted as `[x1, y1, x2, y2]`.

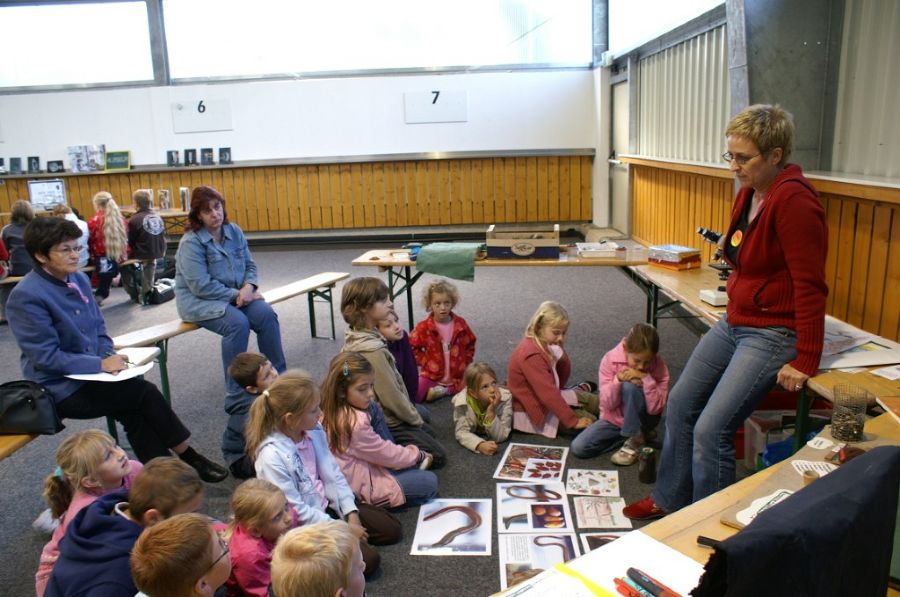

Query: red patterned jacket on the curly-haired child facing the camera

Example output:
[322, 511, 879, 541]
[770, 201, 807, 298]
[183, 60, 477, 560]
[409, 313, 475, 393]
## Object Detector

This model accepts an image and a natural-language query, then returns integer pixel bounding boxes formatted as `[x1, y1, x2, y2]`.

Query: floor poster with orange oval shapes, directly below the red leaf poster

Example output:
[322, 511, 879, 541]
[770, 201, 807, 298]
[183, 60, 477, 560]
[497, 483, 575, 533]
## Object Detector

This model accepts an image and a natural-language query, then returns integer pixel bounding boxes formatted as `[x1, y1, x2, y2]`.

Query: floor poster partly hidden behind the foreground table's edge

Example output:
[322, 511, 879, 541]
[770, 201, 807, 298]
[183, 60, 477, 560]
[497, 533, 579, 589]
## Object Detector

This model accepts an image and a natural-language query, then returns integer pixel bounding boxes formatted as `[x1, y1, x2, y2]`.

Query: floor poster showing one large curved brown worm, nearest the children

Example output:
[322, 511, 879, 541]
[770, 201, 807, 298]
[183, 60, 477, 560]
[410, 499, 492, 556]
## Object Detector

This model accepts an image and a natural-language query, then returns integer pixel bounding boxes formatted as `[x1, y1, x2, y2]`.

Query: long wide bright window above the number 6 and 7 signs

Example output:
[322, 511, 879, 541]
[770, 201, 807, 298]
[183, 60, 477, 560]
[163, 0, 592, 79]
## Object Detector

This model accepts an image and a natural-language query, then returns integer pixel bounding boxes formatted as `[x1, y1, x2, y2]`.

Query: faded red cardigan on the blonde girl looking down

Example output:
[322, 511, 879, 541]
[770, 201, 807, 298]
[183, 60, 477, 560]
[507, 338, 578, 428]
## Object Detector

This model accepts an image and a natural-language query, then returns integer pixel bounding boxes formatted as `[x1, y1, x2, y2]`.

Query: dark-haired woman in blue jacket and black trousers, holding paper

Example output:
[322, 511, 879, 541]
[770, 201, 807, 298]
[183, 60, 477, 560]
[6, 217, 228, 482]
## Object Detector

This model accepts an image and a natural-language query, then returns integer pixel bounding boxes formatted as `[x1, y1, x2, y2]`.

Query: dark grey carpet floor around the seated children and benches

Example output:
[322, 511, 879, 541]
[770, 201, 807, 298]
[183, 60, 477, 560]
[0, 245, 716, 597]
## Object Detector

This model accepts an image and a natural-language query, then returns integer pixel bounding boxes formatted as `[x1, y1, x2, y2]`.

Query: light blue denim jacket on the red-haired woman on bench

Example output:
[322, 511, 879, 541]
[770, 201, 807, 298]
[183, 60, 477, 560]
[175, 224, 258, 322]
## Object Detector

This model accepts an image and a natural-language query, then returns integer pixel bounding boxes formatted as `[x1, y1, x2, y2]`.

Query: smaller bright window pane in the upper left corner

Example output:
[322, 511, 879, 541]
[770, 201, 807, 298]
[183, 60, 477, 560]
[0, 1, 153, 88]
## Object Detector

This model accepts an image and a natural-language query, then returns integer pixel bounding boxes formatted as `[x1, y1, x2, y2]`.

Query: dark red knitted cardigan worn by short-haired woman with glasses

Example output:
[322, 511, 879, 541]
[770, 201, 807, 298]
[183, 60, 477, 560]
[725, 164, 828, 376]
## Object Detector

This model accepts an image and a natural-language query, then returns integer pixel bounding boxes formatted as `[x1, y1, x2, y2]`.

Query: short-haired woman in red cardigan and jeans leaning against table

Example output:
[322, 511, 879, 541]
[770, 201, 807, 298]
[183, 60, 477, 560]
[625, 104, 828, 519]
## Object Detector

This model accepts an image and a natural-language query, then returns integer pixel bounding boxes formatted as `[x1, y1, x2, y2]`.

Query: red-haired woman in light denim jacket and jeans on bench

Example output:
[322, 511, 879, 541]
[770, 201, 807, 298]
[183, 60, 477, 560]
[175, 186, 285, 411]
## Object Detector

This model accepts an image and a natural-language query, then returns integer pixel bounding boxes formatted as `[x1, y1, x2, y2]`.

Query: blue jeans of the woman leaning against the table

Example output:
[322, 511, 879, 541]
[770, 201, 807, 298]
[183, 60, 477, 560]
[651, 318, 797, 512]
